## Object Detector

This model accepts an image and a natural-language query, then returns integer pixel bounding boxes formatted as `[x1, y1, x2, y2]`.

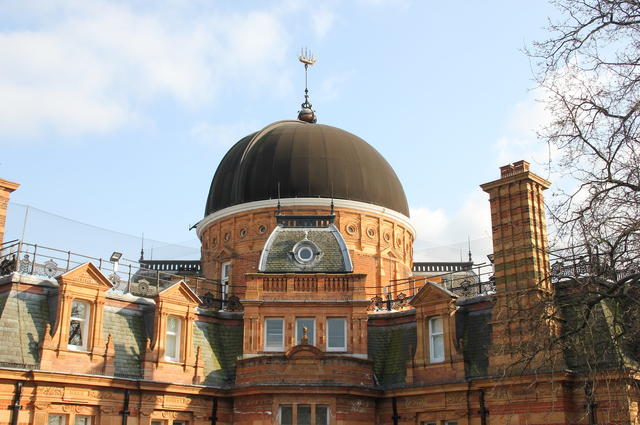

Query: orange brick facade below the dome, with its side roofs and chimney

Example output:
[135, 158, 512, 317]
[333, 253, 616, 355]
[0, 161, 640, 425]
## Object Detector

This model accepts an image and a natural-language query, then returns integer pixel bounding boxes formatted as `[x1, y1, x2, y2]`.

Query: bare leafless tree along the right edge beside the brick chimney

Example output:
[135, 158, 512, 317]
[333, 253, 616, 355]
[523, 0, 640, 423]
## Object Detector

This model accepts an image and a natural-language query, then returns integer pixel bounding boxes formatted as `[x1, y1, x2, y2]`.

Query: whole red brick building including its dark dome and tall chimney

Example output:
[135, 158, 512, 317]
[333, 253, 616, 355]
[0, 117, 638, 425]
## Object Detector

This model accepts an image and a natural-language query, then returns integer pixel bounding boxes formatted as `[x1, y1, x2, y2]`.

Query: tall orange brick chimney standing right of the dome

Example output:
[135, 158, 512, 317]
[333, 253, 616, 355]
[480, 161, 552, 373]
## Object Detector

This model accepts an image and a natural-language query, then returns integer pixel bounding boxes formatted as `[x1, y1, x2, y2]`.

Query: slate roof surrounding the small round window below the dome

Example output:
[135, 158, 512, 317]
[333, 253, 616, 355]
[260, 225, 352, 273]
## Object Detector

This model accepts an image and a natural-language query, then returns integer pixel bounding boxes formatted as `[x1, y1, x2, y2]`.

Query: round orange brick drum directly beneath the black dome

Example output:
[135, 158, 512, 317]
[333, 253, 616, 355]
[200, 205, 415, 299]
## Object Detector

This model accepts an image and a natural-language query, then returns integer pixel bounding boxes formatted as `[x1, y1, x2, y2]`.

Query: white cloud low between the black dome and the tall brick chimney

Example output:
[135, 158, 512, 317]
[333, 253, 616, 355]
[411, 190, 491, 261]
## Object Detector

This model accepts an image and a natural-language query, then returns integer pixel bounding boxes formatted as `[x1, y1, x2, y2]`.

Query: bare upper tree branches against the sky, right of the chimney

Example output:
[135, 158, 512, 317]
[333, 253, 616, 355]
[529, 0, 640, 276]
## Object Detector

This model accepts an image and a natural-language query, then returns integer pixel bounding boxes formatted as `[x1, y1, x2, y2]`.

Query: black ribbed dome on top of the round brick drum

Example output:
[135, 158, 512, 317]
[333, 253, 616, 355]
[205, 121, 409, 217]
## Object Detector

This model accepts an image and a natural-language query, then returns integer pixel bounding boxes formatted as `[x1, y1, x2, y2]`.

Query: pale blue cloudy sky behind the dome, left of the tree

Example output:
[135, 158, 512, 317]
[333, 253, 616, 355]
[0, 0, 554, 260]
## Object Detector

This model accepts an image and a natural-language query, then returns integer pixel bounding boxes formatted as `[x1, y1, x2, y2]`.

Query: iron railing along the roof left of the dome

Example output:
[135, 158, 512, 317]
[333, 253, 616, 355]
[0, 240, 226, 308]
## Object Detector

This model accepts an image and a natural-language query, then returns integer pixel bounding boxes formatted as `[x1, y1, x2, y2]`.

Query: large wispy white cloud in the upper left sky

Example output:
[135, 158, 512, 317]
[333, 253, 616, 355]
[0, 0, 294, 141]
